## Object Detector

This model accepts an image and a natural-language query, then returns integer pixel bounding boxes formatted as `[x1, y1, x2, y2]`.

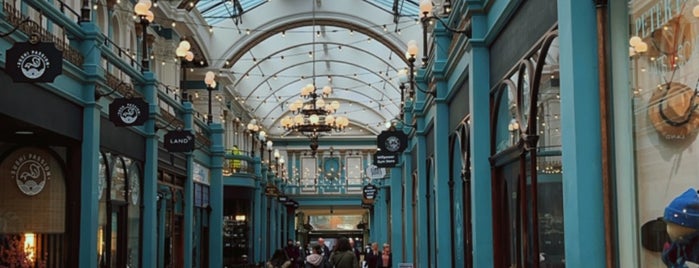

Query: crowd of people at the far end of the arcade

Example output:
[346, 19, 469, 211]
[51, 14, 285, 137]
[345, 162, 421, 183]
[266, 237, 393, 268]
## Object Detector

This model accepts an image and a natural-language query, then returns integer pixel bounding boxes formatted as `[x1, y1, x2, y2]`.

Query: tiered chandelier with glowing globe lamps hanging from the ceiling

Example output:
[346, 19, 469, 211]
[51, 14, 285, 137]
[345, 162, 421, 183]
[281, 4, 349, 155]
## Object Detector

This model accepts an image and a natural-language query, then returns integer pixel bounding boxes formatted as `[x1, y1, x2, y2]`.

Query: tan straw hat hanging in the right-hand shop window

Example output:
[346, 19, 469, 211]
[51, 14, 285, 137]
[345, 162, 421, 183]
[648, 82, 699, 140]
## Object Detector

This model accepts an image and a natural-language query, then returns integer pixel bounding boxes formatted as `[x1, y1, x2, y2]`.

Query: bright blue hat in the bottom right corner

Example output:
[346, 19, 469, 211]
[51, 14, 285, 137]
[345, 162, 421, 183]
[664, 188, 699, 229]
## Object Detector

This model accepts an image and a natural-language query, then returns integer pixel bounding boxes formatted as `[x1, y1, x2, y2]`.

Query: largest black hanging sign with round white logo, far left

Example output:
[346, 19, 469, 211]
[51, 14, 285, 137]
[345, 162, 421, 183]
[5, 42, 63, 82]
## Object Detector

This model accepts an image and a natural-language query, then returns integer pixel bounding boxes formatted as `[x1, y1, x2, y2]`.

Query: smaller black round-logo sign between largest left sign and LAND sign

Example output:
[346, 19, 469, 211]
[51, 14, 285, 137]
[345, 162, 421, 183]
[109, 98, 148, 127]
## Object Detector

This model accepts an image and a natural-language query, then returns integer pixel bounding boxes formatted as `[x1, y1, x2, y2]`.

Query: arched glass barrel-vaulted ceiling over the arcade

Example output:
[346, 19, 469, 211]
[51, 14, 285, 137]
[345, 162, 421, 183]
[196, 0, 430, 137]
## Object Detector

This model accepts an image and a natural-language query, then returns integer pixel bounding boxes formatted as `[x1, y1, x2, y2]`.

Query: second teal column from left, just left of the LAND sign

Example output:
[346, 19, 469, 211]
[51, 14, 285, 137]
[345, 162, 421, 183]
[141, 72, 160, 267]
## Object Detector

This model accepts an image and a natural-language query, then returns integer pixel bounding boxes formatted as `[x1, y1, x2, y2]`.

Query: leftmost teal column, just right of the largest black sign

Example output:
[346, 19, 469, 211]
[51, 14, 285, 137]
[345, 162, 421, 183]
[79, 19, 102, 267]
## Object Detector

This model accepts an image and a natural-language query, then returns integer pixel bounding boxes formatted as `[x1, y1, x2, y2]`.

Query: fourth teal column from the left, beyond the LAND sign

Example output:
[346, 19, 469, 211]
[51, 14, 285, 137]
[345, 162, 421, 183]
[209, 123, 225, 267]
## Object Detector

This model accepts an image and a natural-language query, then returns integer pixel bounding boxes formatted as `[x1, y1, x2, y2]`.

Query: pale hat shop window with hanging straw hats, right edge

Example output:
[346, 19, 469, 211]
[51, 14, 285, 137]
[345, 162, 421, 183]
[628, 0, 699, 267]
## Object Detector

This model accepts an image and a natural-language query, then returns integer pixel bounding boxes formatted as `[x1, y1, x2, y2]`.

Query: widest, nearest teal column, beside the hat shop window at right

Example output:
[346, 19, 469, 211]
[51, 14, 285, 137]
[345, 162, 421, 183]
[558, 1, 605, 268]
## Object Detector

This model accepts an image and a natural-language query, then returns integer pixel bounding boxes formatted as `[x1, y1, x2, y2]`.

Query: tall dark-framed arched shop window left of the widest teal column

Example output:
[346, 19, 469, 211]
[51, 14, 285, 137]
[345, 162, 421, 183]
[492, 29, 565, 268]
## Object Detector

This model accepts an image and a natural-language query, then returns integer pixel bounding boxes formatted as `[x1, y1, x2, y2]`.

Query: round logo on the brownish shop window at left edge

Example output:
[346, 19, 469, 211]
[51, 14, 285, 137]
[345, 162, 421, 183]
[10, 153, 51, 195]
